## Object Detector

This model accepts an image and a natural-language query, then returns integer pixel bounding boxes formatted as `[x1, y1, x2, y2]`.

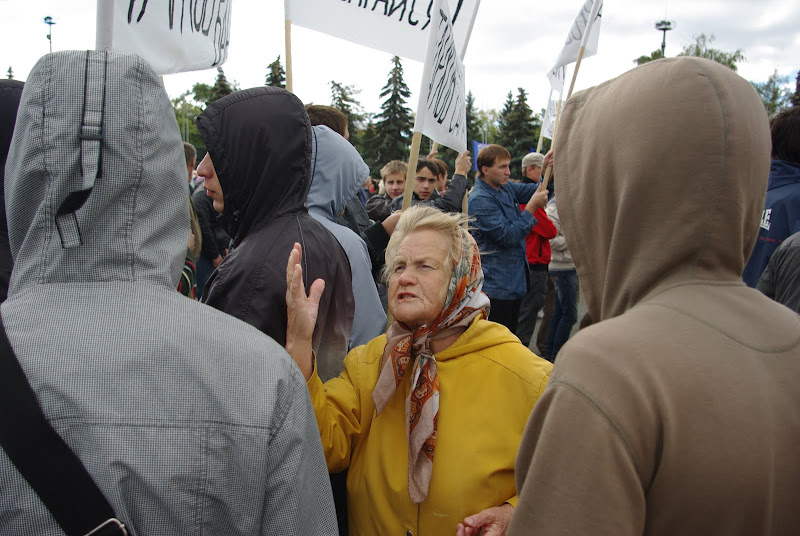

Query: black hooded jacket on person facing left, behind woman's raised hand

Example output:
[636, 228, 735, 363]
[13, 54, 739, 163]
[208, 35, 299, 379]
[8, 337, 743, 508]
[197, 87, 355, 379]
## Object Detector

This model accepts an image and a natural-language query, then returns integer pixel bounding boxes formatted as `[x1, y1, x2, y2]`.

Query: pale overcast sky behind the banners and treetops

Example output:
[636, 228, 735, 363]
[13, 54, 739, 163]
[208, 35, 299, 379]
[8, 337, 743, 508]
[0, 0, 800, 113]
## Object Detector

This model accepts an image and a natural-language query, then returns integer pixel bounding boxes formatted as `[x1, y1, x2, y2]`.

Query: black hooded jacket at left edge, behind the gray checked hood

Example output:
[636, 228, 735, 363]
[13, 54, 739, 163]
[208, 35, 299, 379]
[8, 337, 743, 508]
[0, 80, 24, 302]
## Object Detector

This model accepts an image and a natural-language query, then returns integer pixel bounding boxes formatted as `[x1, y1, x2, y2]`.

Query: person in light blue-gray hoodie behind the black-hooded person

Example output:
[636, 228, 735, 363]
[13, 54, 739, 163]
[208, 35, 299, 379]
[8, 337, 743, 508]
[307, 125, 386, 351]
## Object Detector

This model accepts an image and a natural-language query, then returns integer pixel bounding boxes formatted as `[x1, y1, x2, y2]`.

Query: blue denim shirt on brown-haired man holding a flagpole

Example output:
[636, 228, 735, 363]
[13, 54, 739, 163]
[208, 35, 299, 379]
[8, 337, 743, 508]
[469, 178, 538, 300]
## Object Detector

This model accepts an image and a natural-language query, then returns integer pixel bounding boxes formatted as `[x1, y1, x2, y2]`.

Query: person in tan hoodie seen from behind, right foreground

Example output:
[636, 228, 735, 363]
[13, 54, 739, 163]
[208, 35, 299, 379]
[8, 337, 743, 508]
[507, 57, 800, 536]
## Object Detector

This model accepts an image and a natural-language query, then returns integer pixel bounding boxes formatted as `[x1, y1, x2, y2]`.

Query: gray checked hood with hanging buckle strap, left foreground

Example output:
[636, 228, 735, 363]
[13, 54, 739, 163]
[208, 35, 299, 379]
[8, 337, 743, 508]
[5, 51, 189, 296]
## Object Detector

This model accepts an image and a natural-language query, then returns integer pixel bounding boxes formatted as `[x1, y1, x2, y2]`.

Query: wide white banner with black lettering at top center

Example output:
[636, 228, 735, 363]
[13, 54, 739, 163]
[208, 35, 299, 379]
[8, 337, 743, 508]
[284, 0, 480, 61]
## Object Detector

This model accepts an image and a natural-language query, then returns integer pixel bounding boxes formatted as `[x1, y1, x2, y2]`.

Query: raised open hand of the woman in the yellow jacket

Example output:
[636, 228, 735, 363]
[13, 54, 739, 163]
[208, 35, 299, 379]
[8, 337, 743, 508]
[285, 242, 325, 381]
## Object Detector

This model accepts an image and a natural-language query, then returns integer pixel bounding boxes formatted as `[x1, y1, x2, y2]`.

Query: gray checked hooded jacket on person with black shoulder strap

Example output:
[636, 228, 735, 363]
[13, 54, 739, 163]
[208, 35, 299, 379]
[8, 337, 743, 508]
[0, 51, 336, 535]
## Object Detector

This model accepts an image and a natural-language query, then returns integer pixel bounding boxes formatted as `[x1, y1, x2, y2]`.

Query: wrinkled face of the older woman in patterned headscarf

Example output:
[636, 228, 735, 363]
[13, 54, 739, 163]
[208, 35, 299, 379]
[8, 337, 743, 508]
[389, 230, 451, 330]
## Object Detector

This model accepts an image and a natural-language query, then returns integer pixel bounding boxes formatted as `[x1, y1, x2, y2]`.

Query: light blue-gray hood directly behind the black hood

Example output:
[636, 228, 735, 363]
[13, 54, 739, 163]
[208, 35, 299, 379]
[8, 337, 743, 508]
[308, 125, 369, 222]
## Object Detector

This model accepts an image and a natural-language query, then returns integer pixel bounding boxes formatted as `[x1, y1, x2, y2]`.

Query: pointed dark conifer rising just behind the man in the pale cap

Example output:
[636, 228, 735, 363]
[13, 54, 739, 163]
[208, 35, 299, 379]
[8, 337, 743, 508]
[497, 88, 541, 180]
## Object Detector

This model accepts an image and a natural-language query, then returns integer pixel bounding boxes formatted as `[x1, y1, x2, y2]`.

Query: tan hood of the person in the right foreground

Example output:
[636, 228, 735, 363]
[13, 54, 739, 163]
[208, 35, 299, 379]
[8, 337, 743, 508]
[555, 57, 770, 321]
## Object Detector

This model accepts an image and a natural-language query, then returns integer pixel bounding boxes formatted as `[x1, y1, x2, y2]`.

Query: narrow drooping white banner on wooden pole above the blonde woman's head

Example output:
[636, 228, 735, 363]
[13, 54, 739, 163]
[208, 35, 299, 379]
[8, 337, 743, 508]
[414, 0, 467, 153]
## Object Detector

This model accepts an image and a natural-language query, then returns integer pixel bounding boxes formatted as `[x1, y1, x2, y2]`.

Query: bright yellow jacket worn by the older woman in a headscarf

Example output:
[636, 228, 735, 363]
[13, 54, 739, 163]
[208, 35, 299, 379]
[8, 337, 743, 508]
[308, 320, 552, 536]
